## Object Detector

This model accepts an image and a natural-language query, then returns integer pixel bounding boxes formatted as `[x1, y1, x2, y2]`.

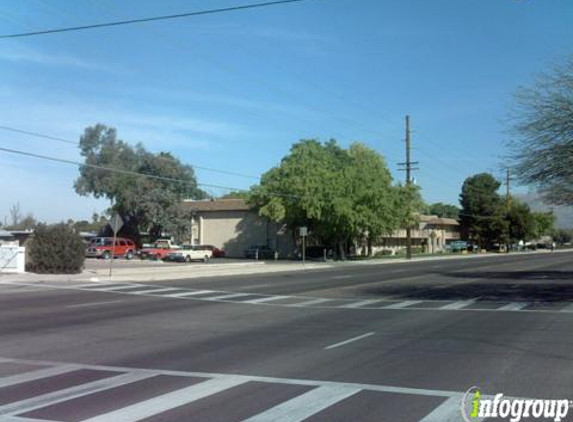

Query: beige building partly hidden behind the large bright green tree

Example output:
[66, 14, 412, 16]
[184, 199, 460, 258]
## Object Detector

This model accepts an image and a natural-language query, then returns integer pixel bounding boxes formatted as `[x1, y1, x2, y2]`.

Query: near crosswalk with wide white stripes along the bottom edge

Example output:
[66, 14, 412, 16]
[0, 359, 472, 422]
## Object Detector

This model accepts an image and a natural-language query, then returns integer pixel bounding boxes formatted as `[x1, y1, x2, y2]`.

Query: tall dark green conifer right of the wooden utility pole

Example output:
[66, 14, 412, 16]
[460, 173, 508, 248]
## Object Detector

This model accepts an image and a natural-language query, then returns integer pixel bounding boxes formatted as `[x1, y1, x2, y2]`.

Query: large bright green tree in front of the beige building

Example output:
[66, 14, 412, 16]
[250, 140, 412, 258]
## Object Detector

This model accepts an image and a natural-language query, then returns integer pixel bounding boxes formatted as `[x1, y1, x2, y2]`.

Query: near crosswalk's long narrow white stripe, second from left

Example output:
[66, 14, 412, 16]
[0, 373, 154, 420]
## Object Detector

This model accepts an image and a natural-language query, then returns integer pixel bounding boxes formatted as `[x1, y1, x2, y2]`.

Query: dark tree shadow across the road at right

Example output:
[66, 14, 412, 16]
[362, 271, 573, 302]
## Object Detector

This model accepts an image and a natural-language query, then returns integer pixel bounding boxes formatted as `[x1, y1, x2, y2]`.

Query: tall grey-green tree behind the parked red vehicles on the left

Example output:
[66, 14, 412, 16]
[75, 124, 206, 243]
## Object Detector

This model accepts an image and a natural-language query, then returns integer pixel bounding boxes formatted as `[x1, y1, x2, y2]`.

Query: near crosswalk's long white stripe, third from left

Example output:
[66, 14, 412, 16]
[82, 376, 245, 422]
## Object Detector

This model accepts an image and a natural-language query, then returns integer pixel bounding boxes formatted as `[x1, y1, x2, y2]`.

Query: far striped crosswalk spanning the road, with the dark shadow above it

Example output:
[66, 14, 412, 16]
[0, 282, 573, 314]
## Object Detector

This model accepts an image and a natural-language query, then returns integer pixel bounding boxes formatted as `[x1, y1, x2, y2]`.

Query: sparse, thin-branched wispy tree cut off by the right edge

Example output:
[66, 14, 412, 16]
[510, 56, 573, 205]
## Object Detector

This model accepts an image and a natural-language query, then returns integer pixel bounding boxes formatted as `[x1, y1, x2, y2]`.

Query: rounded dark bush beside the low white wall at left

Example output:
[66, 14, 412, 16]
[27, 224, 86, 274]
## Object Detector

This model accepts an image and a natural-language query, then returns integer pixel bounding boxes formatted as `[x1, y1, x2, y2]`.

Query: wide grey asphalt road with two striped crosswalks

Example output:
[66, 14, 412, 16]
[0, 253, 573, 422]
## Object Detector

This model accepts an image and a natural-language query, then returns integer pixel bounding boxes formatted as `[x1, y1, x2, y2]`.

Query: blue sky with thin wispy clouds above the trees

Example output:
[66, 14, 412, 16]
[0, 0, 573, 222]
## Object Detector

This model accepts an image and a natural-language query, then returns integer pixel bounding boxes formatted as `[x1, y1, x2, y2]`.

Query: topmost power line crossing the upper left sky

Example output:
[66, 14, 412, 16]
[0, 0, 320, 39]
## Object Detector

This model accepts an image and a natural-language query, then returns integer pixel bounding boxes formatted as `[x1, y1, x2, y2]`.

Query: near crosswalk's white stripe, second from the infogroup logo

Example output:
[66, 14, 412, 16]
[239, 386, 360, 422]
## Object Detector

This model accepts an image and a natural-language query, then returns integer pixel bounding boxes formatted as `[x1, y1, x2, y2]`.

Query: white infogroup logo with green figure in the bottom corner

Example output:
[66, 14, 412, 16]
[460, 387, 572, 422]
